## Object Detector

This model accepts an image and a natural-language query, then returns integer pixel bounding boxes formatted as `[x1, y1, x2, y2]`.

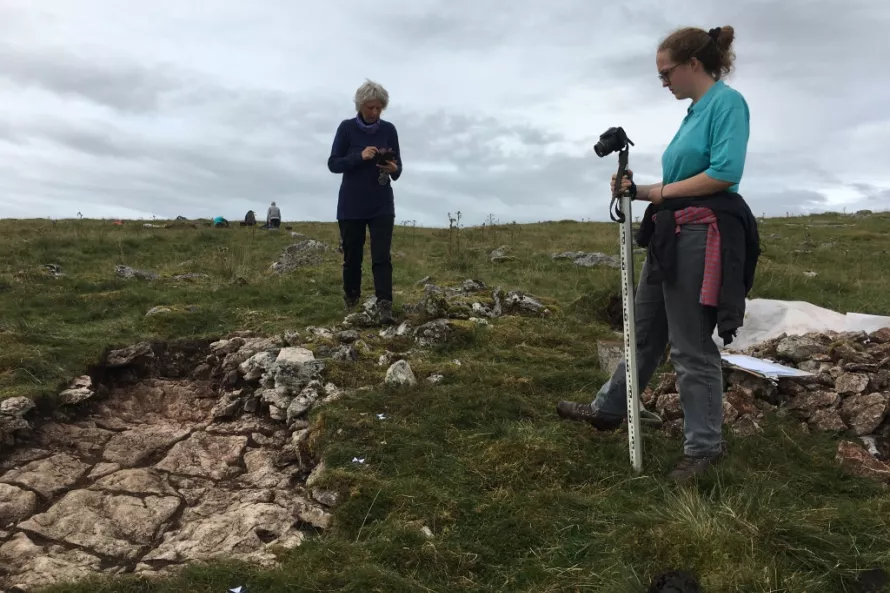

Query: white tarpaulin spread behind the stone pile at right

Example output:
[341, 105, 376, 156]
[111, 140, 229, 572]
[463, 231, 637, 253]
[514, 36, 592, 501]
[714, 299, 890, 351]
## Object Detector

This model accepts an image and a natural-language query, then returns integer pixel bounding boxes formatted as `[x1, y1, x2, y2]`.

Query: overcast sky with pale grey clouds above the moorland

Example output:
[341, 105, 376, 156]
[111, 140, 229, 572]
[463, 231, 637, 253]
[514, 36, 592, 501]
[0, 0, 890, 226]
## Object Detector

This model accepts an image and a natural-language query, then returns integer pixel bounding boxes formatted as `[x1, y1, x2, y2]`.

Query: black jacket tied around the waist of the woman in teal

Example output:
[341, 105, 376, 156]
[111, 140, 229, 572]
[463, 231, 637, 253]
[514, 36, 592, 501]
[637, 192, 760, 344]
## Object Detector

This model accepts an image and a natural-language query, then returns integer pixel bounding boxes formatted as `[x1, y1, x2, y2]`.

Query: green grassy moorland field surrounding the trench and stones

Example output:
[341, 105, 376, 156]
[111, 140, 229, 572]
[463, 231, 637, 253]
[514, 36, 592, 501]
[0, 215, 890, 593]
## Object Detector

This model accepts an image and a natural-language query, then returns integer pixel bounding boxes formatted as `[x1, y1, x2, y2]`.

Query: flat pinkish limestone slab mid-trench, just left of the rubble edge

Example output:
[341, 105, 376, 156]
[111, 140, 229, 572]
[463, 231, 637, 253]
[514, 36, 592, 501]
[155, 432, 247, 480]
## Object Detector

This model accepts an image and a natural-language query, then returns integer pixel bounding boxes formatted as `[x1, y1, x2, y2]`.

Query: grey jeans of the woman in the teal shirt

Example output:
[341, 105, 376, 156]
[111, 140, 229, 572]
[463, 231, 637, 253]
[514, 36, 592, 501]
[593, 224, 723, 455]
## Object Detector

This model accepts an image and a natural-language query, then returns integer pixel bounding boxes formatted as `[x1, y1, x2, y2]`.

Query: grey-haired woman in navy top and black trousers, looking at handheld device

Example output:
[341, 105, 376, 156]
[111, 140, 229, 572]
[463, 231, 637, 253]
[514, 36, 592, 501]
[328, 80, 402, 324]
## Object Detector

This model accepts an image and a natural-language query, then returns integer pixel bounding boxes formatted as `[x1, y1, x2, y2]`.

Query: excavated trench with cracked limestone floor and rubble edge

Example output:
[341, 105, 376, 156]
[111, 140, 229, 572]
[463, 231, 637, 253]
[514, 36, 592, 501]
[0, 337, 339, 591]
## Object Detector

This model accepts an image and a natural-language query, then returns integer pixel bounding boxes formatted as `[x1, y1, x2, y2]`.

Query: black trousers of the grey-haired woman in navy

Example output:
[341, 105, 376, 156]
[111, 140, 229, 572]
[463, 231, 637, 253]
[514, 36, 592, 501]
[339, 216, 395, 302]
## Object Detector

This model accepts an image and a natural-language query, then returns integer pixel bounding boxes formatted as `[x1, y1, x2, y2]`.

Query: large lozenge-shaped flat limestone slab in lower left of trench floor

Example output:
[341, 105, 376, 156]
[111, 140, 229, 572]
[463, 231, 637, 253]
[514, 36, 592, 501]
[19, 490, 180, 560]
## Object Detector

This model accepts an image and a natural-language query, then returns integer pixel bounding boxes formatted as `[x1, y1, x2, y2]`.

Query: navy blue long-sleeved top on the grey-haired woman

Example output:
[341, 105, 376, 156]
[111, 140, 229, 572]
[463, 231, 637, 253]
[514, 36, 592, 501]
[328, 118, 402, 220]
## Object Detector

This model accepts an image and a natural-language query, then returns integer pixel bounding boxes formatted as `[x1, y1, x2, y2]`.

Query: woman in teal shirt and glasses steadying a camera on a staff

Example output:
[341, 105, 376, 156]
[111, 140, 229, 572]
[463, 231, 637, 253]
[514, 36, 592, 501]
[557, 27, 760, 480]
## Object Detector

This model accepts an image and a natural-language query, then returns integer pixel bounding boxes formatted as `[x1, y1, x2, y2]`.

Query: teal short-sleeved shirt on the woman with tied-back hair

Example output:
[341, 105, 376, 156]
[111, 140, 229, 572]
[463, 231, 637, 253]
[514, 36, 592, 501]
[661, 80, 750, 192]
